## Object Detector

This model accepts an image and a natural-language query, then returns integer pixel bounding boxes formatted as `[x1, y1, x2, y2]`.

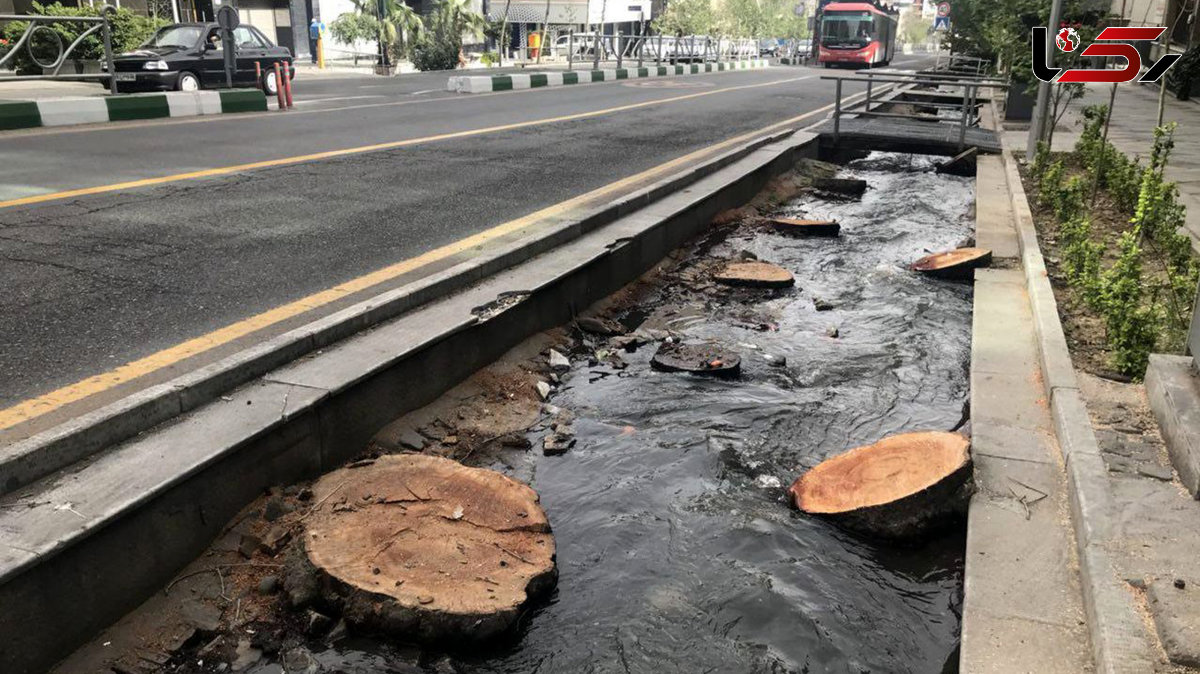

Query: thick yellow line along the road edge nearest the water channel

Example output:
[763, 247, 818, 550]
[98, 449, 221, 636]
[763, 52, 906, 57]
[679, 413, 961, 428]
[0, 78, 862, 431]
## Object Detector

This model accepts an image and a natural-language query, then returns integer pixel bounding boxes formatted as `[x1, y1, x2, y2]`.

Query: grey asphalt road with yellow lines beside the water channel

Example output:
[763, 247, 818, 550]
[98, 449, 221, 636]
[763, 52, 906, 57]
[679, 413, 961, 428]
[0, 60, 936, 443]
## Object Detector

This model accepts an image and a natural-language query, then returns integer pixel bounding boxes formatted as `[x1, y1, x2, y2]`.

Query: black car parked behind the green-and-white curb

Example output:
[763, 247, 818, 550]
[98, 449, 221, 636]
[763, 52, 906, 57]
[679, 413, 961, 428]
[104, 23, 295, 95]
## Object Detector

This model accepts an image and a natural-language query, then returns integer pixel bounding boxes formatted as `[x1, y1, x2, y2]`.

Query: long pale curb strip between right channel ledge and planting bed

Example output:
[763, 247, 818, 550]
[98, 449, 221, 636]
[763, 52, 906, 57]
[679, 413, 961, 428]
[1002, 119, 1157, 674]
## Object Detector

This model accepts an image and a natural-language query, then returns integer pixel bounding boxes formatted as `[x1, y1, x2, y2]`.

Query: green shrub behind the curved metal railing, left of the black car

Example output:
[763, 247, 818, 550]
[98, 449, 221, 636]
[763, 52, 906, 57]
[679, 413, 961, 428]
[0, 2, 170, 74]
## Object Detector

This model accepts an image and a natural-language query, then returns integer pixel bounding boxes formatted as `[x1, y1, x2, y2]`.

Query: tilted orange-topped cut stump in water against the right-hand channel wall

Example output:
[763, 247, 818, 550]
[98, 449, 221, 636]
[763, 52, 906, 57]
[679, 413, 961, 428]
[788, 432, 972, 538]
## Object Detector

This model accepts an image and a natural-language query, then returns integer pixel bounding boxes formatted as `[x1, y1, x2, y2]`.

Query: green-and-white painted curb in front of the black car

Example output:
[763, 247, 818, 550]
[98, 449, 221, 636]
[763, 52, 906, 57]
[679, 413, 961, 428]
[0, 89, 266, 131]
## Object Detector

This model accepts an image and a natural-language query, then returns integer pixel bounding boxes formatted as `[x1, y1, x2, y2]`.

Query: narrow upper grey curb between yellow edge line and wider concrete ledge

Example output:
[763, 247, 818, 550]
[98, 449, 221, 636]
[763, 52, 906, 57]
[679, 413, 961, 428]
[0, 131, 806, 494]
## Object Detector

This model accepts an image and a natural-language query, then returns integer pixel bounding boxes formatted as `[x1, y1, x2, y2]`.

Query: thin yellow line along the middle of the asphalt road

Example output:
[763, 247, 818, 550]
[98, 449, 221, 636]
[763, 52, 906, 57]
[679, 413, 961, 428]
[0, 76, 812, 209]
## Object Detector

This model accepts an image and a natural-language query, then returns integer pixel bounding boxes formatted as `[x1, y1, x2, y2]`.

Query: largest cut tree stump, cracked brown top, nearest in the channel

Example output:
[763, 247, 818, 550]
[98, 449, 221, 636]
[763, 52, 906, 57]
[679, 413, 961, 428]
[304, 455, 558, 643]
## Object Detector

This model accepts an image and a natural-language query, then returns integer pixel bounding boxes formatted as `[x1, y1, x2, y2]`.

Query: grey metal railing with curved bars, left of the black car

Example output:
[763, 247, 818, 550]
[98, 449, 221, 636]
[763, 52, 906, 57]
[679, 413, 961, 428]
[0, 5, 116, 94]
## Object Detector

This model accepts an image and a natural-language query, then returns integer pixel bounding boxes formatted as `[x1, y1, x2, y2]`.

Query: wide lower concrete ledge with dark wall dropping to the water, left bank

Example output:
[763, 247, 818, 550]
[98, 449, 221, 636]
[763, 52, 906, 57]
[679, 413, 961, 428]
[0, 128, 817, 674]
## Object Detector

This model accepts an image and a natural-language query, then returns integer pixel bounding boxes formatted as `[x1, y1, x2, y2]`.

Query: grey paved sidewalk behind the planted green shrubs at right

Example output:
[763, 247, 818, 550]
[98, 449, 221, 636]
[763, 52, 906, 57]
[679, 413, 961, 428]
[1065, 84, 1200, 252]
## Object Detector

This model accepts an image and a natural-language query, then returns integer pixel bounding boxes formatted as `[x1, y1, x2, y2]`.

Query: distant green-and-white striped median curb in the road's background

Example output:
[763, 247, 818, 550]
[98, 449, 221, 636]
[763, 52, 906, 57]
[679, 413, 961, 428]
[446, 59, 768, 94]
